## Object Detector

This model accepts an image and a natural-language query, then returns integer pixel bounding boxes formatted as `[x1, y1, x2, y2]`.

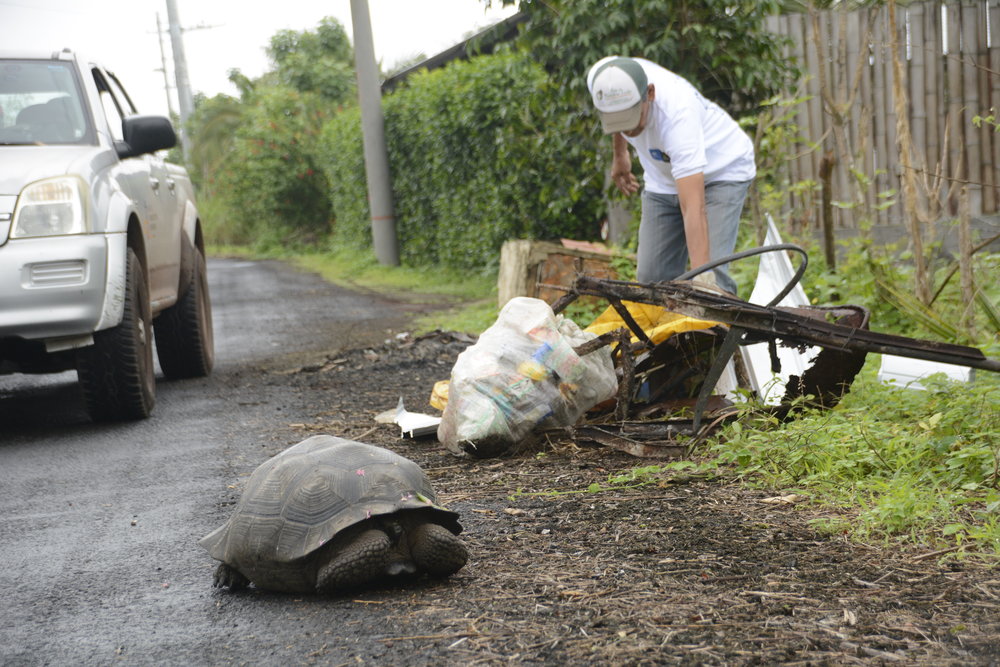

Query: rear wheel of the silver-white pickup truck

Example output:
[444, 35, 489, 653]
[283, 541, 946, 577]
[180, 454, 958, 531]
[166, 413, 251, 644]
[153, 248, 215, 380]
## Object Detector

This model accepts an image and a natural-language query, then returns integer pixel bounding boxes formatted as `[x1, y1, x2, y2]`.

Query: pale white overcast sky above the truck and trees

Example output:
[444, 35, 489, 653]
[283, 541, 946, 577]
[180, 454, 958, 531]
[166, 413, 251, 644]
[0, 0, 514, 114]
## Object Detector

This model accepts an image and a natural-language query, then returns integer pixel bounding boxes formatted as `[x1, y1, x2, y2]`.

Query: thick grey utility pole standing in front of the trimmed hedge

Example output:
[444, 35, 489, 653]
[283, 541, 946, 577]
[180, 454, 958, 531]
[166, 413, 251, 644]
[352, 0, 399, 266]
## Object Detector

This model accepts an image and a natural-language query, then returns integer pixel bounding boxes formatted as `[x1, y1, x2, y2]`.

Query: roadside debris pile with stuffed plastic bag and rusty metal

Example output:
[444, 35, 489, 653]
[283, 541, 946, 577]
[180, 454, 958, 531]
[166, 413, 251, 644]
[426, 244, 1000, 457]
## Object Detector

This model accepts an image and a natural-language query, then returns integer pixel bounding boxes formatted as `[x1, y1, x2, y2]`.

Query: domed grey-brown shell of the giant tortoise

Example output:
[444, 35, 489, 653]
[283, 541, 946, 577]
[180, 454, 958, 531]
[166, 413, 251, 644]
[200, 435, 462, 579]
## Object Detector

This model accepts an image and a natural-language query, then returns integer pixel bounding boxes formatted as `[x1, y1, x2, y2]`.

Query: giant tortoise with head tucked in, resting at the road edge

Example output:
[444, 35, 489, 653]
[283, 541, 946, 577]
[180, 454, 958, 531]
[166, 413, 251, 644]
[200, 435, 468, 593]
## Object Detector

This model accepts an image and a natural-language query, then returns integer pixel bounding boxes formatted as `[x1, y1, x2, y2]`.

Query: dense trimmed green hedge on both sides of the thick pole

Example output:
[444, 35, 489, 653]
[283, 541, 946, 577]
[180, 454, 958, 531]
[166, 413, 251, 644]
[320, 54, 610, 270]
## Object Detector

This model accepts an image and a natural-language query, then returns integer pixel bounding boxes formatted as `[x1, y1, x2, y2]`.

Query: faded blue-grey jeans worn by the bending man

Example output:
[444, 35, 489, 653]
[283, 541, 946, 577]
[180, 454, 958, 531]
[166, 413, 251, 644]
[636, 181, 751, 294]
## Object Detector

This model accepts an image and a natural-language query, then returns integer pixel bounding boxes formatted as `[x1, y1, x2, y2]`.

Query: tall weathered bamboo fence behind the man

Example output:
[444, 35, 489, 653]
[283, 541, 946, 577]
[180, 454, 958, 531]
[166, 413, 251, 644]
[768, 0, 1000, 229]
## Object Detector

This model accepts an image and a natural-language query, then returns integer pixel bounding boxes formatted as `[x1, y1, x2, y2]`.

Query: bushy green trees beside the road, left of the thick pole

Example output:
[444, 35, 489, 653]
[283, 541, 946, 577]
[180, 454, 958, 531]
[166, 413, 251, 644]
[187, 18, 354, 245]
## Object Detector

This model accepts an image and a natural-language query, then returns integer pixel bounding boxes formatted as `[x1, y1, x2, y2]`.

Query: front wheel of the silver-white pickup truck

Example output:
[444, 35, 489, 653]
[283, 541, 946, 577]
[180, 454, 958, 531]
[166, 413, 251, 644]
[76, 248, 156, 421]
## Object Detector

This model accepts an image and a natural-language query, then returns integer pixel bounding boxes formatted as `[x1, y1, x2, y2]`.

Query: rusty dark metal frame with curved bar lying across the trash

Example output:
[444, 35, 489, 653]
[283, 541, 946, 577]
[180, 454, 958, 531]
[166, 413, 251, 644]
[553, 244, 1000, 449]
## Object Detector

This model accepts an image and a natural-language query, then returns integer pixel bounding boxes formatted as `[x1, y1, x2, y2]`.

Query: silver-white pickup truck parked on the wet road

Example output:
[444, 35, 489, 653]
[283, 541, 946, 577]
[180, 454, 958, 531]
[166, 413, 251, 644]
[0, 50, 214, 421]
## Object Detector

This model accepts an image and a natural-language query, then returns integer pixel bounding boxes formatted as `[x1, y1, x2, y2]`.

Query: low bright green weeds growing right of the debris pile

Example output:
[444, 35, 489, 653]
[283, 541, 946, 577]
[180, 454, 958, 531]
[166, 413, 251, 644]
[710, 370, 1000, 555]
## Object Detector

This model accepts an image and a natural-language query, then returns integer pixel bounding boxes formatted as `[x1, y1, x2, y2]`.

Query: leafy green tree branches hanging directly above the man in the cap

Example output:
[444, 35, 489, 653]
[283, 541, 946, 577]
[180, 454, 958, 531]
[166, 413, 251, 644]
[486, 0, 790, 115]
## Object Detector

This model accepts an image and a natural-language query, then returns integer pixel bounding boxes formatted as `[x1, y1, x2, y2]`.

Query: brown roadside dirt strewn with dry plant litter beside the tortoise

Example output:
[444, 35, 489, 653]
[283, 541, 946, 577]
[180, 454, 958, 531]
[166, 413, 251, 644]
[262, 334, 1000, 665]
